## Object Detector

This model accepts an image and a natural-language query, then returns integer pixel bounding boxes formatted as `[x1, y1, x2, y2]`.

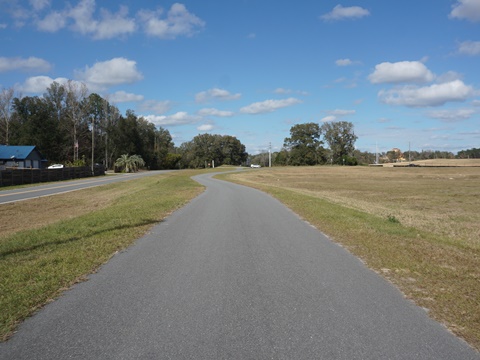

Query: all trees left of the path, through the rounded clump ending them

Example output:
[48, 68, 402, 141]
[0, 81, 248, 169]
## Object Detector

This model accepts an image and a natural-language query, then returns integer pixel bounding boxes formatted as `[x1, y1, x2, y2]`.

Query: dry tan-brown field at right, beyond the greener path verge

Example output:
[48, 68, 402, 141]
[236, 167, 480, 249]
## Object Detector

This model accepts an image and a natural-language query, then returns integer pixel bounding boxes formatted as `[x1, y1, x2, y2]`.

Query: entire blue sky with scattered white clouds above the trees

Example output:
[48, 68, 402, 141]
[0, 0, 480, 154]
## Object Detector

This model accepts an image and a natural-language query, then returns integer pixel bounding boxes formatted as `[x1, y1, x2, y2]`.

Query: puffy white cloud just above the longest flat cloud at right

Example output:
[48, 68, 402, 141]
[368, 61, 435, 84]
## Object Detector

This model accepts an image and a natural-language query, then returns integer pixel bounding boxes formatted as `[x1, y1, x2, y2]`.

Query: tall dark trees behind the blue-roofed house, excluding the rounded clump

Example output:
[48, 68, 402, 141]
[0, 81, 177, 169]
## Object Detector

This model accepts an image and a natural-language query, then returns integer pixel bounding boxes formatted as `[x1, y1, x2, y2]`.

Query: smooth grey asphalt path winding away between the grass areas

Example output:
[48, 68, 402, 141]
[0, 175, 480, 360]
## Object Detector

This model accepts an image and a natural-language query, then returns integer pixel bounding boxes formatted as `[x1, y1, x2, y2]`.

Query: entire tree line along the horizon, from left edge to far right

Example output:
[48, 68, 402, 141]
[0, 80, 472, 169]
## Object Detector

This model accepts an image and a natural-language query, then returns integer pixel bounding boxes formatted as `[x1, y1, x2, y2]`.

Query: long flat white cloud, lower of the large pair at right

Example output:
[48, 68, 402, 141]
[378, 80, 475, 107]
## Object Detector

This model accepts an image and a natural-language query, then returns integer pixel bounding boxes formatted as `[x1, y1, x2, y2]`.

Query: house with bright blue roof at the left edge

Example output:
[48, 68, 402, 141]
[0, 145, 47, 170]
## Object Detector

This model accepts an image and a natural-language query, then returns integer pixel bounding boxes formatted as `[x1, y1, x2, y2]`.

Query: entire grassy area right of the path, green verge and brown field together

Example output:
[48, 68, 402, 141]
[224, 162, 480, 349]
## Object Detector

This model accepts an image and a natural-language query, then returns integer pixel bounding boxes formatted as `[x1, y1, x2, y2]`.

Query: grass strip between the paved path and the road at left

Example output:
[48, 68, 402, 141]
[0, 171, 203, 340]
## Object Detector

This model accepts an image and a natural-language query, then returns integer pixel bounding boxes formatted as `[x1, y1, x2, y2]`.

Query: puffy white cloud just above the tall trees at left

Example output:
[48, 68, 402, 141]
[75, 58, 143, 90]
